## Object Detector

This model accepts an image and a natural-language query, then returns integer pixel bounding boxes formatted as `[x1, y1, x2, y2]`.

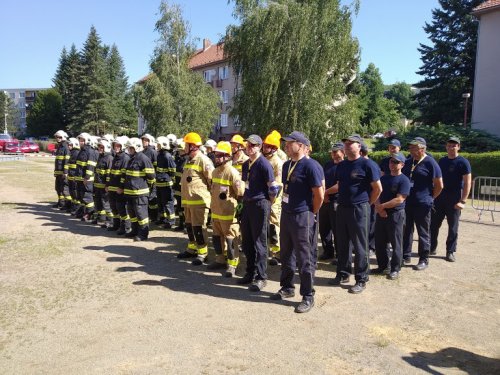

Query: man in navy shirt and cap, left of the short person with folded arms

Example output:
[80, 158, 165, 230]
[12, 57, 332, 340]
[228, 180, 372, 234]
[329, 134, 382, 293]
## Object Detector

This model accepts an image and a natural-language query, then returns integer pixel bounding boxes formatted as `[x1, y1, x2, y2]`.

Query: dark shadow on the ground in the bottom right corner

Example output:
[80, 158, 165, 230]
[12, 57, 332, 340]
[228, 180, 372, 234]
[403, 348, 500, 375]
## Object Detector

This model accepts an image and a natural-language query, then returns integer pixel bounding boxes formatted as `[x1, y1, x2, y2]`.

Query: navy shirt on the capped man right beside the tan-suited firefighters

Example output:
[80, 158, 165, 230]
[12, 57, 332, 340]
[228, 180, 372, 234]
[241, 155, 274, 200]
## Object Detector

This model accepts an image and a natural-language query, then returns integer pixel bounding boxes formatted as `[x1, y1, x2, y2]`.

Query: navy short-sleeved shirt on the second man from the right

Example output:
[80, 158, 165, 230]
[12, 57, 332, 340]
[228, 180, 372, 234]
[402, 156, 442, 206]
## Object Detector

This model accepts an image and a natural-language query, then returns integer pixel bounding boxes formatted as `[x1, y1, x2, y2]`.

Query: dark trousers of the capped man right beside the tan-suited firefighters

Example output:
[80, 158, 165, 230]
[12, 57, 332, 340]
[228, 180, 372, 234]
[240, 199, 271, 280]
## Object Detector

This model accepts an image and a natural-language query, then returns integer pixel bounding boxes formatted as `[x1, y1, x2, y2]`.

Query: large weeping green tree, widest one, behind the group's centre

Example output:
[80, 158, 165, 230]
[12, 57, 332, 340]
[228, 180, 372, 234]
[224, 0, 359, 148]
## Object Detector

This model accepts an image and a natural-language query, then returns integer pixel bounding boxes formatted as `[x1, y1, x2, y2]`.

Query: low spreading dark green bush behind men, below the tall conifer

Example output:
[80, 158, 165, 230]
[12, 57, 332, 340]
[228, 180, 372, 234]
[375, 124, 500, 152]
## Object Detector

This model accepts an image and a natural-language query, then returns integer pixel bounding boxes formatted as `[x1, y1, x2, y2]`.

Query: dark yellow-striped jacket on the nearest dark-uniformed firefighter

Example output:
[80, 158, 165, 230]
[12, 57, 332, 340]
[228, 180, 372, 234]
[120, 152, 156, 197]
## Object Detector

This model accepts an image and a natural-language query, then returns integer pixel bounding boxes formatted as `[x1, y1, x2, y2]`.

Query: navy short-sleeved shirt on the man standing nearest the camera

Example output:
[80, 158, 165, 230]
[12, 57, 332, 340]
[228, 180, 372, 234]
[281, 157, 325, 214]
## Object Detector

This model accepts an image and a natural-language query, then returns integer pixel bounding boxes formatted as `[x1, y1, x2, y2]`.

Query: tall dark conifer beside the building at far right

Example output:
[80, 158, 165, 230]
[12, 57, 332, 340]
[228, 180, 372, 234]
[416, 0, 483, 124]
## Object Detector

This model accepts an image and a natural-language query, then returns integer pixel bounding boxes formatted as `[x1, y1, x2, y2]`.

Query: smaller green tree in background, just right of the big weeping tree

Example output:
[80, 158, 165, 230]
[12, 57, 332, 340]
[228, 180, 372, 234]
[359, 63, 401, 134]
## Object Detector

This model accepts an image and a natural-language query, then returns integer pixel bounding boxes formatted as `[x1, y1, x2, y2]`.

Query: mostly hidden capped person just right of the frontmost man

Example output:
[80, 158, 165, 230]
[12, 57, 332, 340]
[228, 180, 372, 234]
[318, 142, 344, 263]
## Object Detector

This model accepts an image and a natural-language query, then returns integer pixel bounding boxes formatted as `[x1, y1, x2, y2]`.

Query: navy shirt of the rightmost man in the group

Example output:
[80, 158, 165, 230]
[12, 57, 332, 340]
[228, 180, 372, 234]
[439, 156, 471, 202]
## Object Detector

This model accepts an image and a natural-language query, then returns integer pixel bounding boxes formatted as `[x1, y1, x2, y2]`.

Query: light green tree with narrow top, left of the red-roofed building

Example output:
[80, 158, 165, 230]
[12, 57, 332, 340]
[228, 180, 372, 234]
[134, 1, 219, 136]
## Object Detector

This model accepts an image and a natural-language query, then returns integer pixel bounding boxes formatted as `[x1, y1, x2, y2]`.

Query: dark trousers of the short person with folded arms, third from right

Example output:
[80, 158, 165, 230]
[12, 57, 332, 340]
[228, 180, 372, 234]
[375, 210, 406, 272]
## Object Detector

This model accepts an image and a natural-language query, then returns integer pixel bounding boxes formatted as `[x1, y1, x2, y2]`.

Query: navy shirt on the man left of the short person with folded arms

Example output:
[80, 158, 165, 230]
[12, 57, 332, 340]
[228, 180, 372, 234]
[334, 157, 380, 206]
